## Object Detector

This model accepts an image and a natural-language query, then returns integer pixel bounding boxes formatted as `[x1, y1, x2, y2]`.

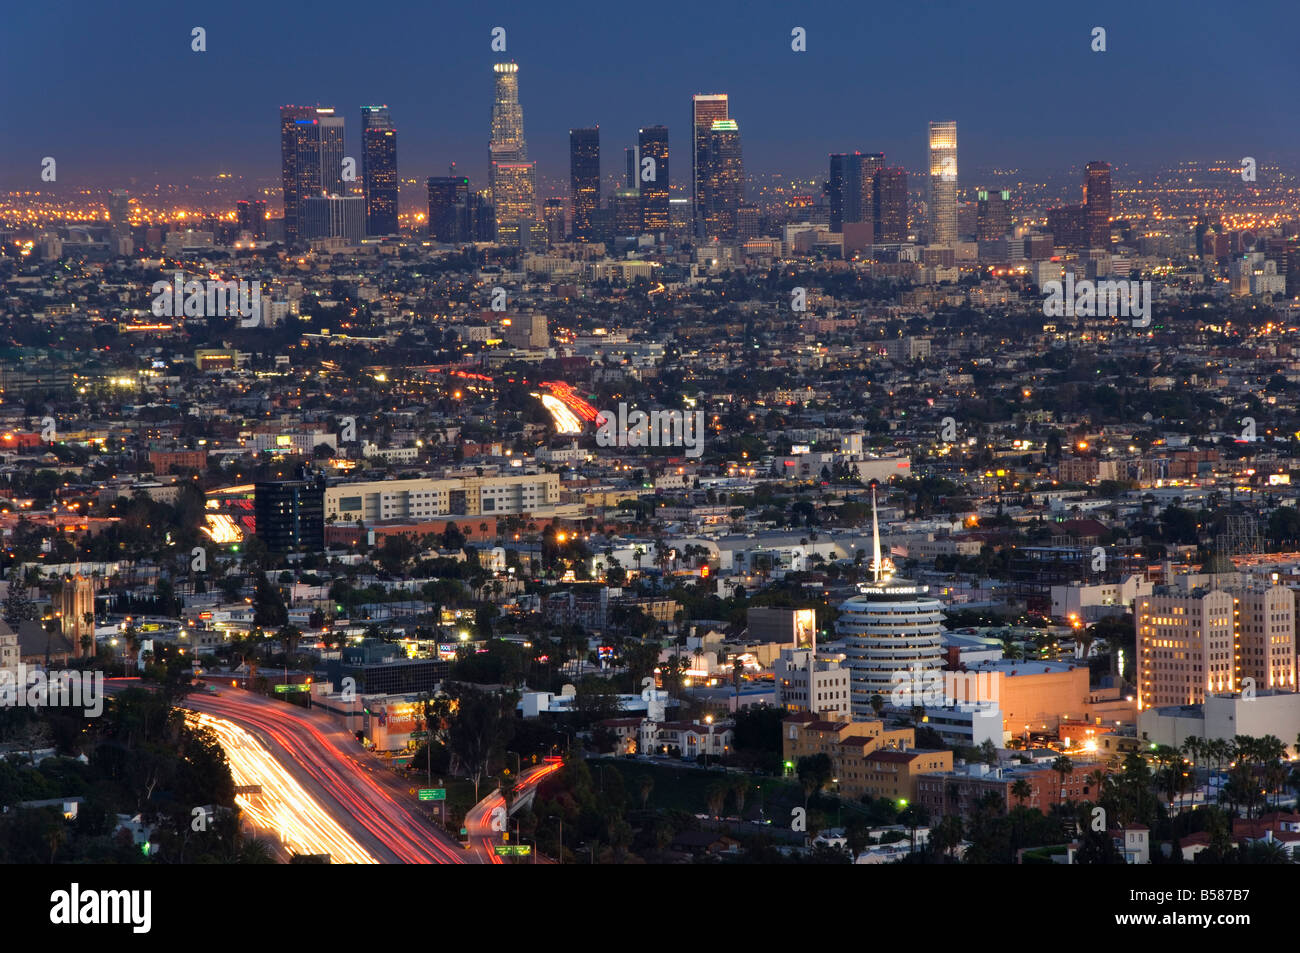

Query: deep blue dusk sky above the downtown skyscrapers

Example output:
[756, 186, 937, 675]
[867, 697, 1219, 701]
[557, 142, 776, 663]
[0, 0, 1300, 190]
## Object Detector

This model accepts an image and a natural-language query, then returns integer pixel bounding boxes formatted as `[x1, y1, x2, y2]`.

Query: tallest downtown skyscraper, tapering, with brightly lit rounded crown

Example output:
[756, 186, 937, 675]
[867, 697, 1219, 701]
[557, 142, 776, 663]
[488, 62, 545, 246]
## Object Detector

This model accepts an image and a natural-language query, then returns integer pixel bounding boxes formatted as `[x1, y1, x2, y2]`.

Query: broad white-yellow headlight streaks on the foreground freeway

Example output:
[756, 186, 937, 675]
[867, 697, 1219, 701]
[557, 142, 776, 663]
[189, 712, 378, 863]
